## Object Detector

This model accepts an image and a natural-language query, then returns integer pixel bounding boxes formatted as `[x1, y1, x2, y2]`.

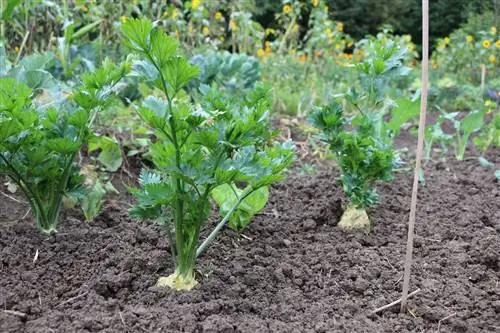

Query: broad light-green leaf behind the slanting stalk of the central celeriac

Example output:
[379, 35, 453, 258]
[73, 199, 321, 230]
[211, 184, 269, 232]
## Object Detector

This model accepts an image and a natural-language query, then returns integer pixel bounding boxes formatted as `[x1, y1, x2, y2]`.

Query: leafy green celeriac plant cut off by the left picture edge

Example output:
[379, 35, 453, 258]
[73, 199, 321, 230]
[0, 62, 127, 234]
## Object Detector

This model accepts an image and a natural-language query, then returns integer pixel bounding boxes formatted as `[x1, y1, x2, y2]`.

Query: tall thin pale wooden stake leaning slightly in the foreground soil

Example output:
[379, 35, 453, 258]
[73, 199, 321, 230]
[401, 0, 429, 312]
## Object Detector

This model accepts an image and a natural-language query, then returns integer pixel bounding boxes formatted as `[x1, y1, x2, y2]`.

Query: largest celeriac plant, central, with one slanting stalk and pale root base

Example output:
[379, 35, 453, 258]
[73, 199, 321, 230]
[122, 19, 294, 290]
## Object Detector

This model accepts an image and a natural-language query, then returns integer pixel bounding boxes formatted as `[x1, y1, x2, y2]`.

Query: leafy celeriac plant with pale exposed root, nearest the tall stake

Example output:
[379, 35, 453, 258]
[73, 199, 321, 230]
[310, 42, 410, 229]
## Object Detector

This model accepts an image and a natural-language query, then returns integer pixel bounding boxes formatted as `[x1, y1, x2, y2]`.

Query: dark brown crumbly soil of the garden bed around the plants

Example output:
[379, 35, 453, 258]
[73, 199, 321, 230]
[0, 151, 500, 333]
